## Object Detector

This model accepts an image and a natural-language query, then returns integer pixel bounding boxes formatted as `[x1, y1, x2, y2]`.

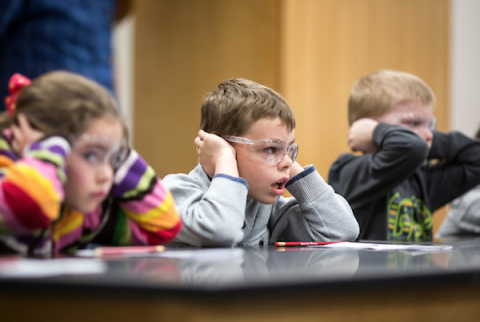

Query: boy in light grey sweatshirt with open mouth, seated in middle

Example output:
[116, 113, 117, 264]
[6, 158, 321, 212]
[164, 79, 358, 247]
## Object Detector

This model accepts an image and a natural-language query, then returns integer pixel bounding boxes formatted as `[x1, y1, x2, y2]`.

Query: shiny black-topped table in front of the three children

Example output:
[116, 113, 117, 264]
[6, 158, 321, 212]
[0, 239, 480, 322]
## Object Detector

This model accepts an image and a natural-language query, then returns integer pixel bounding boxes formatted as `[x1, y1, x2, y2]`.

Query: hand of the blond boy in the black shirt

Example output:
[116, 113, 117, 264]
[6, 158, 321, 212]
[348, 118, 378, 153]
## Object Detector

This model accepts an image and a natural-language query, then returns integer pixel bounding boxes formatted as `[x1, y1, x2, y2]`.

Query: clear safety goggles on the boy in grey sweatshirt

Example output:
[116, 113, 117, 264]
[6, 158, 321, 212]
[221, 135, 298, 165]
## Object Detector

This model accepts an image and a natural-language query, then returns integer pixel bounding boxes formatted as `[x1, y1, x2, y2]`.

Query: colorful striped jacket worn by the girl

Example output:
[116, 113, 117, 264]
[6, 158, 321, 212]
[0, 137, 182, 255]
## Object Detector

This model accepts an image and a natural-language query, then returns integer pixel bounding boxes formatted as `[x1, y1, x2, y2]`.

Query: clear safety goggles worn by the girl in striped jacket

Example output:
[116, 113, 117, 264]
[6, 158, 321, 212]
[71, 133, 128, 169]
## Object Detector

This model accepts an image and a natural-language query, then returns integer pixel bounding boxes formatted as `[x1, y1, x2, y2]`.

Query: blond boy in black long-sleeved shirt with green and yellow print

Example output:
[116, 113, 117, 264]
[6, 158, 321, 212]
[328, 70, 480, 241]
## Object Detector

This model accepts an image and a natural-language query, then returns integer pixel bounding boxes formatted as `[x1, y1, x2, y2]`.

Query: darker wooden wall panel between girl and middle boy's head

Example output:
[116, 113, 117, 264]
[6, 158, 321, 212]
[134, 0, 280, 177]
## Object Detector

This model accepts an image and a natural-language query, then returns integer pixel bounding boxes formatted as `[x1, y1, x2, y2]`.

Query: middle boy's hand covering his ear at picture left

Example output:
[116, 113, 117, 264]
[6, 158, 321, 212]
[194, 130, 238, 178]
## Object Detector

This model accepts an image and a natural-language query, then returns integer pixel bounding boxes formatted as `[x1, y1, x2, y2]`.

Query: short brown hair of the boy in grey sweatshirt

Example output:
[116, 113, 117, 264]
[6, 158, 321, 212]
[200, 78, 295, 135]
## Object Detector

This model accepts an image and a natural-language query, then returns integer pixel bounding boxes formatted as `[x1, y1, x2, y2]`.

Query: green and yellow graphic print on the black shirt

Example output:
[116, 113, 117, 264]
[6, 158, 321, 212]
[387, 192, 433, 241]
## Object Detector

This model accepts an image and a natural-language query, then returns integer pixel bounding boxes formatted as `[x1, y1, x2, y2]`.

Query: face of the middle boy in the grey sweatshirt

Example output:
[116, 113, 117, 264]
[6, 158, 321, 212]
[233, 117, 295, 204]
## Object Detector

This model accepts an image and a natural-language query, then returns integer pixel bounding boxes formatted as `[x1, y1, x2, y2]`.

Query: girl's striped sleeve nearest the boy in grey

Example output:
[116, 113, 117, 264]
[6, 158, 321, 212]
[110, 150, 182, 245]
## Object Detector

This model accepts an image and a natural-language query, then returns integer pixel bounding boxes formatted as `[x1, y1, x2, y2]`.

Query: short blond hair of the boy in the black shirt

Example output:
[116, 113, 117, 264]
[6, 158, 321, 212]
[348, 70, 435, 125]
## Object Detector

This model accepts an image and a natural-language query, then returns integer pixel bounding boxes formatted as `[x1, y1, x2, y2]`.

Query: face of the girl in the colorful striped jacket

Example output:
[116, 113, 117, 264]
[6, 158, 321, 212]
[65, 118, 124, 213]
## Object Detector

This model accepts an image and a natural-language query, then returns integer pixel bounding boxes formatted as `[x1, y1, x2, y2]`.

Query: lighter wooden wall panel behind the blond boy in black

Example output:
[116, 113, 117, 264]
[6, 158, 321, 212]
[280, 0, 448, 177]
